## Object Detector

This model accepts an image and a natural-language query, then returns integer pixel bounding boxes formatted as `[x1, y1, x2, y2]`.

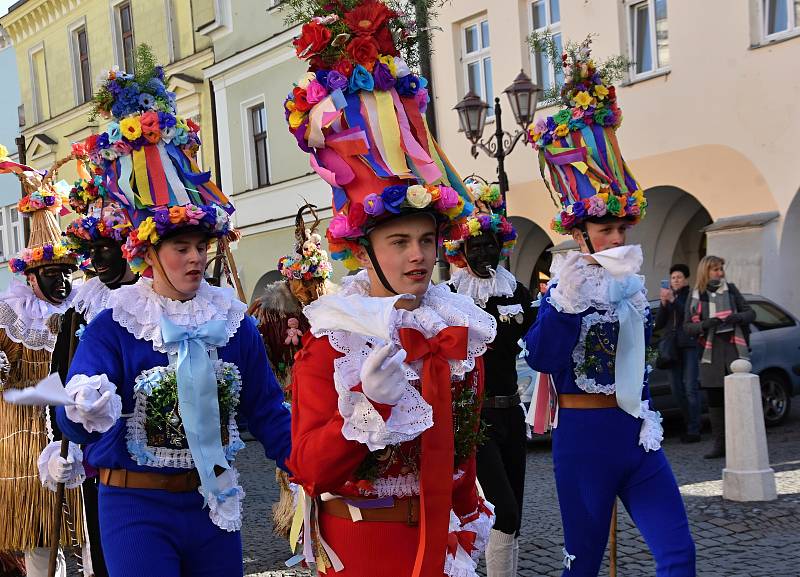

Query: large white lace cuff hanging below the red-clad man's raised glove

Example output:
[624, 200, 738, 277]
[333, 346, 433, 451]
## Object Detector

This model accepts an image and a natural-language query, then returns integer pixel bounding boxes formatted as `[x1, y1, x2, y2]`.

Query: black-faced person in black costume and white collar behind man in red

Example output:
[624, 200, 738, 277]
[444, 179, 535, 577]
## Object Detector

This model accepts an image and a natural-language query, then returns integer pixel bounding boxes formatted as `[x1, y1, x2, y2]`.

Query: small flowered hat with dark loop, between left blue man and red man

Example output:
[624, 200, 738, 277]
[278, 204, 333, 283]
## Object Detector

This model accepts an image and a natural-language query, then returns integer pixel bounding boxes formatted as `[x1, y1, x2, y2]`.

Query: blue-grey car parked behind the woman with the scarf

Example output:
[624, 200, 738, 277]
[650, 294, 800, 427]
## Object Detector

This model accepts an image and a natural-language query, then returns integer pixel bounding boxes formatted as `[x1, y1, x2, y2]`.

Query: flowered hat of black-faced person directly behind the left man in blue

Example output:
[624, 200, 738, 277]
[65, 148, 133, 259]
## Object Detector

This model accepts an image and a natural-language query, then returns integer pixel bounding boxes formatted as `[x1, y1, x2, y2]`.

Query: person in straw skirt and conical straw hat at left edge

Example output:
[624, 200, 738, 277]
[0, 147, 83, 575]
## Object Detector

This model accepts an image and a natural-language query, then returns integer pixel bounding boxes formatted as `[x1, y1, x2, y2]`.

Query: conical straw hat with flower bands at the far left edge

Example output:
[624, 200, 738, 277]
[0, 146, 80, 274]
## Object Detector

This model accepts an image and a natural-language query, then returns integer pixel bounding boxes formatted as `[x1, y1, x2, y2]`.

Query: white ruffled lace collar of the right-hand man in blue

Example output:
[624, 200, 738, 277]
[548, 252, 648, 316]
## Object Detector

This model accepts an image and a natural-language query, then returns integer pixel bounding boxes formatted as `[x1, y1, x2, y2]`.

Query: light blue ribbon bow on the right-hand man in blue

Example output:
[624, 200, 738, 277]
[608, 275, 645, 417]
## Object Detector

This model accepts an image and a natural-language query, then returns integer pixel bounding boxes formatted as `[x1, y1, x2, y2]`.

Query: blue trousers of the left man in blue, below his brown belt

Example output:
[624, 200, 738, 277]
[99, 485, 244, 577]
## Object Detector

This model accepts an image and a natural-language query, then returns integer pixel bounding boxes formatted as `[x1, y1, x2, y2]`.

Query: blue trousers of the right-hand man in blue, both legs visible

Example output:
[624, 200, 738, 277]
[553, 409, 695, 577]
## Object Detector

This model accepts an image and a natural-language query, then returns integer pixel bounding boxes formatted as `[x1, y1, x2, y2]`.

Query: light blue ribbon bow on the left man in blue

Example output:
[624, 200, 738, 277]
[161, 317, 230, 499]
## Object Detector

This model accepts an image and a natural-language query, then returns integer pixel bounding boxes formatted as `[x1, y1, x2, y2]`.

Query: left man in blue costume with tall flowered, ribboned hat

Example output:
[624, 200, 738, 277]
[50, 55, 290, 577]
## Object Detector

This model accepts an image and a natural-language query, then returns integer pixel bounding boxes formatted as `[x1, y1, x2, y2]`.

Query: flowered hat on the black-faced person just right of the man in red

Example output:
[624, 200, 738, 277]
[444, 176, 517, 268]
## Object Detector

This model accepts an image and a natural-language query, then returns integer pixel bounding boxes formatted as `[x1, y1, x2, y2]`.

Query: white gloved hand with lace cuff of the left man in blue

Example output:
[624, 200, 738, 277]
[65, 374, 122, 433]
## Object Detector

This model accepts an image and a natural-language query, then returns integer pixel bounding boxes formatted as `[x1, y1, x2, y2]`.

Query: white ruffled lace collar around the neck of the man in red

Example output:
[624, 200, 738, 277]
[303, 271, 497, 379]
